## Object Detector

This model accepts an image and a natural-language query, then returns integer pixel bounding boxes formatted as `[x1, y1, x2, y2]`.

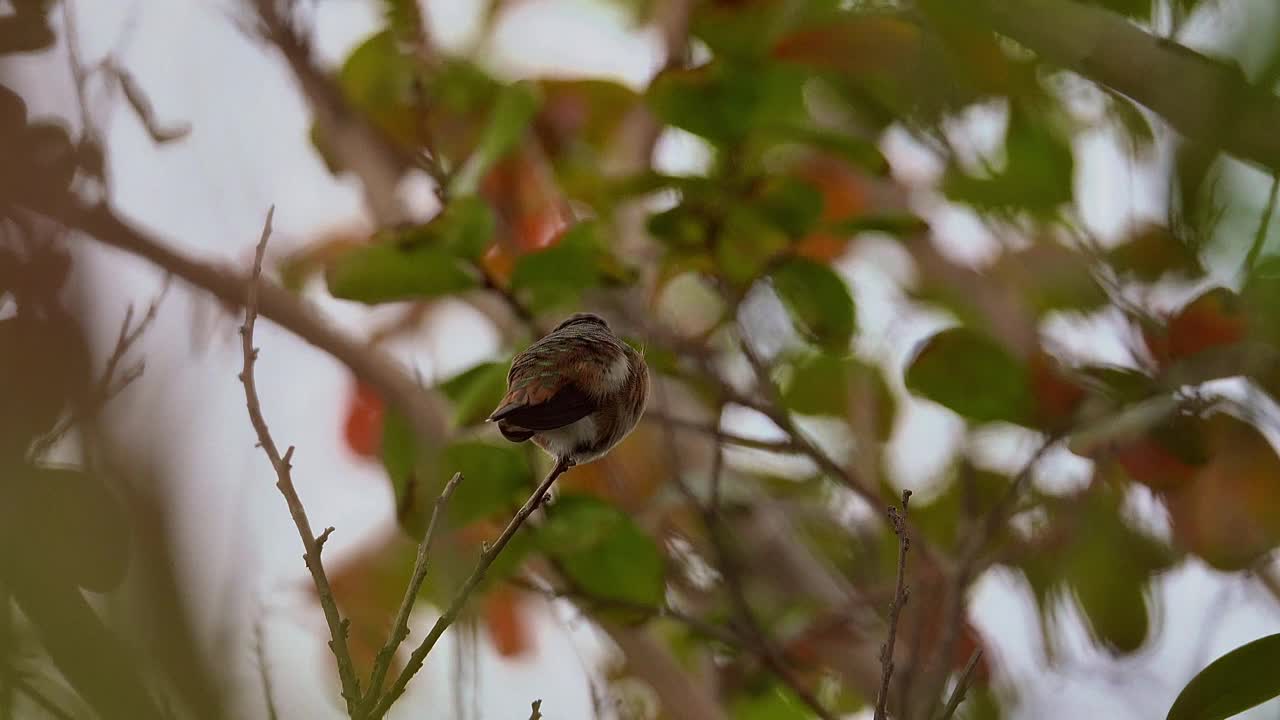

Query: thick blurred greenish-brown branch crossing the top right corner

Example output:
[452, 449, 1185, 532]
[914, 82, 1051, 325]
[966, 0, 1280, 170]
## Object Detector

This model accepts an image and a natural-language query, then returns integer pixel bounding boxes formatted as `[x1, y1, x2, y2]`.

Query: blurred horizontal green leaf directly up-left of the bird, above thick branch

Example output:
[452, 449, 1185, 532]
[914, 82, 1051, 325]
[325, 238, 477, 305]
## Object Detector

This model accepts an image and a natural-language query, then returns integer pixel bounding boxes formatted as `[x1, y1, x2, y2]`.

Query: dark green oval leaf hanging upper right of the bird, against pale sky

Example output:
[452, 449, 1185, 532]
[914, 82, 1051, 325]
[769, 258, 856, 352]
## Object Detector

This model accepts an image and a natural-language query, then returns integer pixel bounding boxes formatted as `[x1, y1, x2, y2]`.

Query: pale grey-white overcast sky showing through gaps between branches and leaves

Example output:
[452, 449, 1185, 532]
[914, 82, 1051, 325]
[22, 0, 1280, 720]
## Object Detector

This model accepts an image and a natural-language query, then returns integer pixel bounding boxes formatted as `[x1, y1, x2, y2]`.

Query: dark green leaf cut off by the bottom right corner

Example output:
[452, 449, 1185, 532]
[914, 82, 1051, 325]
[1167, 634, 1280, 720]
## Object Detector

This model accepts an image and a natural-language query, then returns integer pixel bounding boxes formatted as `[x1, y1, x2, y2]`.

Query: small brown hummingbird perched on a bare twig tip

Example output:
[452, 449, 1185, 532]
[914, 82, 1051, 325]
[488, 313, 649, 466]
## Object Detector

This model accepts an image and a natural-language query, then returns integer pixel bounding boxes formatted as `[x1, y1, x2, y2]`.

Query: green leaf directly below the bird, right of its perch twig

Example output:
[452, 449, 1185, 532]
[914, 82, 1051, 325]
[538, 495, 666, 607]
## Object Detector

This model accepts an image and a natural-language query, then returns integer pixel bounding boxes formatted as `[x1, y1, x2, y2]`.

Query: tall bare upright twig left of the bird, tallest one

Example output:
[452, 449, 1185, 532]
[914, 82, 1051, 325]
[239, 206, 360, 716]
